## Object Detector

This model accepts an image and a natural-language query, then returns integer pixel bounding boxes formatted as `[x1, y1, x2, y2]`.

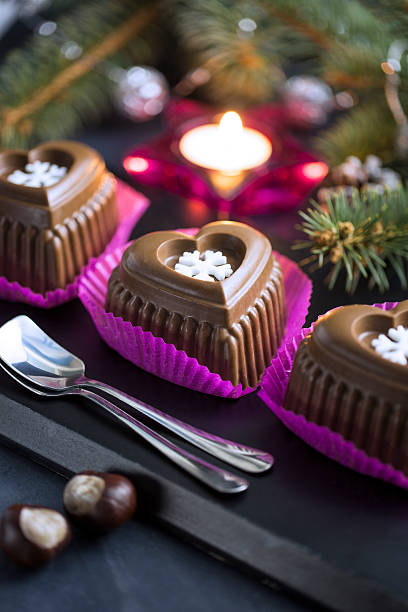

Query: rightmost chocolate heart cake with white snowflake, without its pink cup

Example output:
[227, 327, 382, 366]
[284, 300, 408, 475]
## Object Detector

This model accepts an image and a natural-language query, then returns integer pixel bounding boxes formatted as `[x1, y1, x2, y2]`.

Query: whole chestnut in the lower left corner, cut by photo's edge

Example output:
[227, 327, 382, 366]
[0, 504, 71, 567]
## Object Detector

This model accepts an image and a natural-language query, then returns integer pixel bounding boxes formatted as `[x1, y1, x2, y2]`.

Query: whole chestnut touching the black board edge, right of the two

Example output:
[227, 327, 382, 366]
[64, 471, 137, 533]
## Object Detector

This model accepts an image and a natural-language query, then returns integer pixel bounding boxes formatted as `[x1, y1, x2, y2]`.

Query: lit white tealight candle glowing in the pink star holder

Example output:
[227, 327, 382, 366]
[179, 111, 272, 175]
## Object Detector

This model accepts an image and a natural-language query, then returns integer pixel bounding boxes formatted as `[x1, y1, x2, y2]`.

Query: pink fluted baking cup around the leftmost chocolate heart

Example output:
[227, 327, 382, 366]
[0, 180, 149, 308]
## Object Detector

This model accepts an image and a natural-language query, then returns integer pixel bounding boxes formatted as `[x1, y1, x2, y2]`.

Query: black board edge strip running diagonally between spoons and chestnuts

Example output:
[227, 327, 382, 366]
[0, 397, 407, 612]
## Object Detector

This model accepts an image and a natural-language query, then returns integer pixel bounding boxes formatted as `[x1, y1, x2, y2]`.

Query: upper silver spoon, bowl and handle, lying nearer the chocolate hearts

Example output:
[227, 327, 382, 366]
[0, 315, 274, 473]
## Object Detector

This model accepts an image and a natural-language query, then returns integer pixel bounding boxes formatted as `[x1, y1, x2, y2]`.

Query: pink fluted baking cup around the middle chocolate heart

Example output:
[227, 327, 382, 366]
[78, 229, 312, 398]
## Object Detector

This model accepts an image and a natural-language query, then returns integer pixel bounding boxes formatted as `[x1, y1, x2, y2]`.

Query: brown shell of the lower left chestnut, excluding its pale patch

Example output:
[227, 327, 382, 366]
[0, 504, 72, 567]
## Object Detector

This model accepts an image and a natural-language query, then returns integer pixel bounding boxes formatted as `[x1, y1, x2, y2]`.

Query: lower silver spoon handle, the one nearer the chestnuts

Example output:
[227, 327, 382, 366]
[78, 389, 249, 494]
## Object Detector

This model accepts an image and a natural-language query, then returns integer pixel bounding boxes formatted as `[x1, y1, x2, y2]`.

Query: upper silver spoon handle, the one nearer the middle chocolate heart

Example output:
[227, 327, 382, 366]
[80, 377, 274, 474]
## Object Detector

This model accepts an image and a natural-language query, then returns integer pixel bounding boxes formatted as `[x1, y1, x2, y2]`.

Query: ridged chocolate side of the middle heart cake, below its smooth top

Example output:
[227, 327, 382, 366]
[106, 261, 286, 387]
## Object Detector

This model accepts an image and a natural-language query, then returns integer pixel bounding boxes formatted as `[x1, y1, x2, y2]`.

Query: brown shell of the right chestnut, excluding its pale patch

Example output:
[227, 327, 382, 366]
[64, 470, 137, 533]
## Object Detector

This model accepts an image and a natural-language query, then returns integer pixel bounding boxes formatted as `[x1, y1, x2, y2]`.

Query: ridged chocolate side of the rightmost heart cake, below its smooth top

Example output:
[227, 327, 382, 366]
[284, 337, 408, 475]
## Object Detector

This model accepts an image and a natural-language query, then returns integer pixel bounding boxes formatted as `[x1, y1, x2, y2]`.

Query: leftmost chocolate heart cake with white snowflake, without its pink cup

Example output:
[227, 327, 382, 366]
[0, 141, 117, 293]
